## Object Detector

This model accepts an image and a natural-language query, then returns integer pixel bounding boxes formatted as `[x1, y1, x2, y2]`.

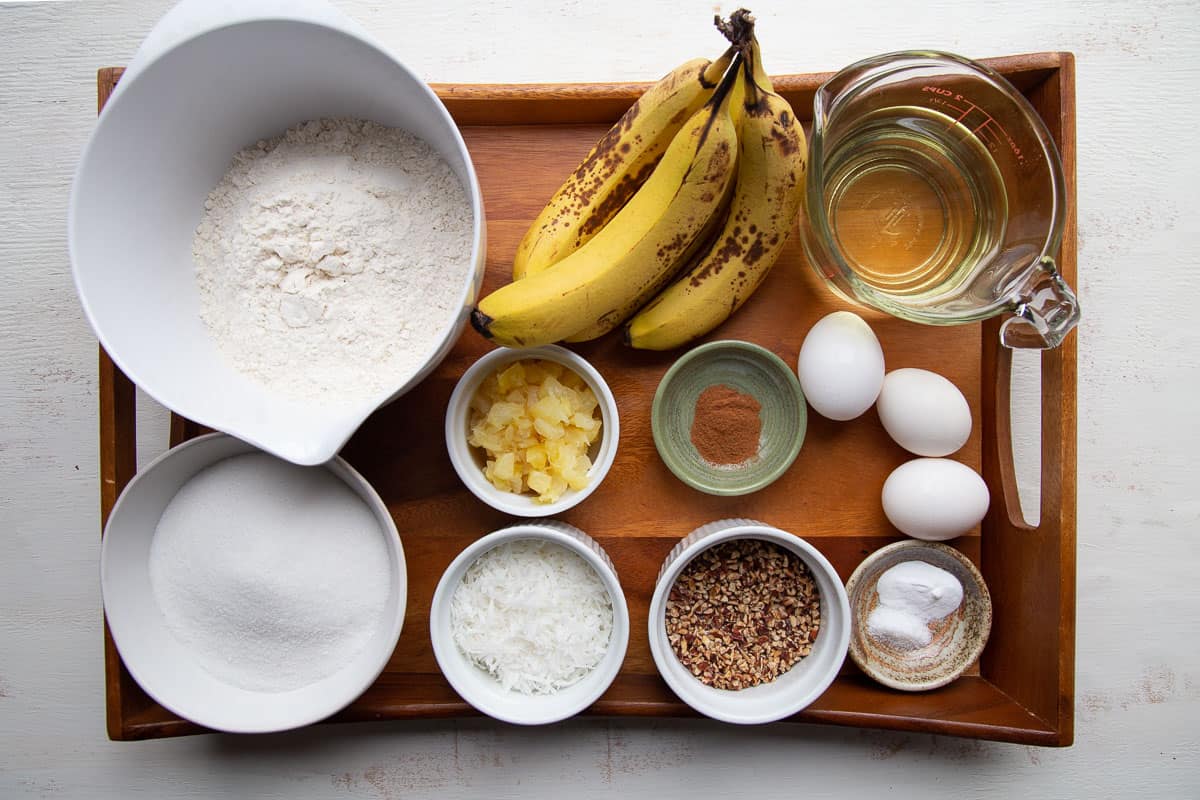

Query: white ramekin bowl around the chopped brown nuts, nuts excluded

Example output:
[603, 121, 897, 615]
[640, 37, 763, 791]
[649, 519, 850, 724]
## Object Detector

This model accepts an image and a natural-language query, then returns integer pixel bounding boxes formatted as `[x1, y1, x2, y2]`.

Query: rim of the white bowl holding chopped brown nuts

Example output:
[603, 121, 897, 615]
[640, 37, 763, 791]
[647, 519, 851, 724]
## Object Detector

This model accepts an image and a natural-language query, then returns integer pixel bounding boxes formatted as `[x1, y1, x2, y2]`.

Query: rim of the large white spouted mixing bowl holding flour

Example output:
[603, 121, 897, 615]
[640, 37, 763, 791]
[67, 13, 487, 467]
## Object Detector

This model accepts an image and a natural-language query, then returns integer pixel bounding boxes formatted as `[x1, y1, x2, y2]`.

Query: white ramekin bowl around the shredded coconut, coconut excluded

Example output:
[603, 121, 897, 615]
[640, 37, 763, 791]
[430, 519, 629, 724]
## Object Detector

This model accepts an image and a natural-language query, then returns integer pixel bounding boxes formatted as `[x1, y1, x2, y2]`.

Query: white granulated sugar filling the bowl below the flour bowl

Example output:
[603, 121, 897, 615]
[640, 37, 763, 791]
[150, 453, 392, 692]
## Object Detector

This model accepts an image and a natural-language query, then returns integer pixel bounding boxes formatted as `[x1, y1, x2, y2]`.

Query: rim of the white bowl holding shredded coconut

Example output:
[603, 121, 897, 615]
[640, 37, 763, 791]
[428, 519, 630, 726]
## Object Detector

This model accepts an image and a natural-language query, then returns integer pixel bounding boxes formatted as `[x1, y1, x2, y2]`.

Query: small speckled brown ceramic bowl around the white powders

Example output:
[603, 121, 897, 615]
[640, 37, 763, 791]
[846, 540, 991, 692]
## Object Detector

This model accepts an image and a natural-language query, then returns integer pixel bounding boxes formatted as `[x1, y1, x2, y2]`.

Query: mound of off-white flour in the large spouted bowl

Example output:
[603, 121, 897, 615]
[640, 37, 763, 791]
[192, 119, 473, 404]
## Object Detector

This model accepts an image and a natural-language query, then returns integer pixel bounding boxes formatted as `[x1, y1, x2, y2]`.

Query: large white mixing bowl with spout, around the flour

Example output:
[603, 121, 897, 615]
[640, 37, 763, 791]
[67, 0, 486, 464]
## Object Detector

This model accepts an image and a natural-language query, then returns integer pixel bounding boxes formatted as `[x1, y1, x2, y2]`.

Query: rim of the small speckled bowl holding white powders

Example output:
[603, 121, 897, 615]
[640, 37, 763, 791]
[846, 539, 992, 692]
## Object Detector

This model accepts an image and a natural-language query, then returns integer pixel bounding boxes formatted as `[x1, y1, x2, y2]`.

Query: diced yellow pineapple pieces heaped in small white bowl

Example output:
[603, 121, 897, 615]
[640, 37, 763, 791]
[467, 360, 601, 503]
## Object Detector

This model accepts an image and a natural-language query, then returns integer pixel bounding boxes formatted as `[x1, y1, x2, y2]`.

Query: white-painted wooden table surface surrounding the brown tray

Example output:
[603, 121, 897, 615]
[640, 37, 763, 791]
[0, 0, 1200, 799]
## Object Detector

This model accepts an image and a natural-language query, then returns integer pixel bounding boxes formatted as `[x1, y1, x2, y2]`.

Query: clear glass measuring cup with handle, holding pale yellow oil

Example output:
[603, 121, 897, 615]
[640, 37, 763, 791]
[800, 52, 1079, 348]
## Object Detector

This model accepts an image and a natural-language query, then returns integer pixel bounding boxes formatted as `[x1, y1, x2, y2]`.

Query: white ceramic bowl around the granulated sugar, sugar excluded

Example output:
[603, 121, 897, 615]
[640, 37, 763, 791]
[100, 433, 408, 733]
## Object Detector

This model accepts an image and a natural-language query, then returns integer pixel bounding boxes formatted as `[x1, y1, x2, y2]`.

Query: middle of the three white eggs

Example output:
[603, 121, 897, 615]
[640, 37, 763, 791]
[875, 368, 971, 456]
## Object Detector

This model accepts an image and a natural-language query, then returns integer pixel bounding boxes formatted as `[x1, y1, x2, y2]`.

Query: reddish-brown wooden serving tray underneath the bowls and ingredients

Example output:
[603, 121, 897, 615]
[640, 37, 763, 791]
[98, 53, 1075, 746]
